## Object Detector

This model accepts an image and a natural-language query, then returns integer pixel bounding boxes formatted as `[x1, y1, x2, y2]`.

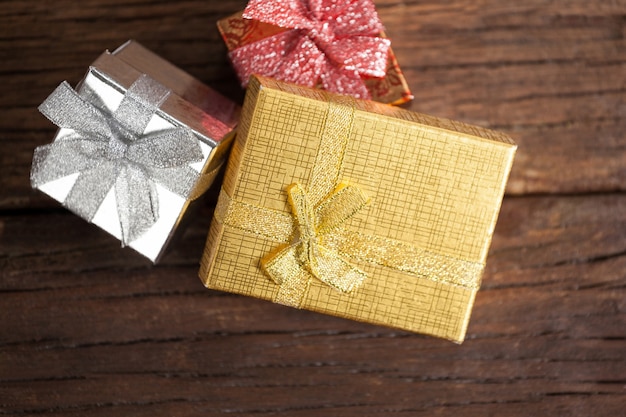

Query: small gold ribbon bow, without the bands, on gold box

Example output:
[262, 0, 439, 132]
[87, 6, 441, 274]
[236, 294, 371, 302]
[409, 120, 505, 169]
[261, 183, 367, 307]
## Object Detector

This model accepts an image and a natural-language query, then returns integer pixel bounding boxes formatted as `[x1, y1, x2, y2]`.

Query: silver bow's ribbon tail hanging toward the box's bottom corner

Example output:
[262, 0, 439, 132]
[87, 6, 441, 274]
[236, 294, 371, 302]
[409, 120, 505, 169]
[115, 166, 159, 245]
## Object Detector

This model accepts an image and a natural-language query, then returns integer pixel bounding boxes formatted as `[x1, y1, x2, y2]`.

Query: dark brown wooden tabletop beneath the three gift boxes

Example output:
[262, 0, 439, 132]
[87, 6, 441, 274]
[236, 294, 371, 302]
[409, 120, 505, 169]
[0, 0, 626, 417]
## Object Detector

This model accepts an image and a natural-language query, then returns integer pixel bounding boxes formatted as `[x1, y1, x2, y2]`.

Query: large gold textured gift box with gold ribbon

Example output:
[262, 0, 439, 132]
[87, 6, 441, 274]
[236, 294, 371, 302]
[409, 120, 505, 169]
[200, 77, 516, 342]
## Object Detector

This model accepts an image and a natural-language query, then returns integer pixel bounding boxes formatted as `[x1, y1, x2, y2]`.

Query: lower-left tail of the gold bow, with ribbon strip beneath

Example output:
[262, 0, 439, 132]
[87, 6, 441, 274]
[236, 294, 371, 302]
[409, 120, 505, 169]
[261, 245, 313, 308]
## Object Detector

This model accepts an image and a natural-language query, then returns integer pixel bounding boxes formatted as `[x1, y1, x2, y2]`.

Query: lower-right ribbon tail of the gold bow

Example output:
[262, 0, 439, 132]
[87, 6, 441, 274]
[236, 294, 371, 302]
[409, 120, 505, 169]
[309, 246, 367, 293]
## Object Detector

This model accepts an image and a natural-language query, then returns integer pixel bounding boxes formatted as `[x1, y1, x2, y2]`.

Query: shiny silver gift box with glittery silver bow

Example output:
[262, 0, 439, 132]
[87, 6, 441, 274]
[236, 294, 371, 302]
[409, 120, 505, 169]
[31, 41, 240, 262]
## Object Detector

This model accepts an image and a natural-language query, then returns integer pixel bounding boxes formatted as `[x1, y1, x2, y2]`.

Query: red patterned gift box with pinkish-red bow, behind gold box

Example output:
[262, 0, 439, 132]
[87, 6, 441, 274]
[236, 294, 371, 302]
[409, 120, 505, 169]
[218, 0, 413, 105]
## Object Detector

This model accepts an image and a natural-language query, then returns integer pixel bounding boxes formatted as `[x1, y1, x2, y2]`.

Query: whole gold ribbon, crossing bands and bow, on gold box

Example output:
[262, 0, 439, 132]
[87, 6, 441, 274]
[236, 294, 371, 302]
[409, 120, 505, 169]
[215, 98, 484, 308]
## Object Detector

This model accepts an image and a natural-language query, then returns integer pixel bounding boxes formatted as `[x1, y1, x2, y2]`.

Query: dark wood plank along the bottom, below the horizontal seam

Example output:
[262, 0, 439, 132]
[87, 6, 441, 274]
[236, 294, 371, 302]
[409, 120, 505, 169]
[0, 194, 626, 416]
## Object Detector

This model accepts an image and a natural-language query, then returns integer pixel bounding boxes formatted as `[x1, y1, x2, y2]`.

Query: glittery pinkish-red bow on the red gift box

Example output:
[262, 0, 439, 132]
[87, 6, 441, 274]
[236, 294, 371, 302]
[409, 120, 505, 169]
[230, 0, 390, 98]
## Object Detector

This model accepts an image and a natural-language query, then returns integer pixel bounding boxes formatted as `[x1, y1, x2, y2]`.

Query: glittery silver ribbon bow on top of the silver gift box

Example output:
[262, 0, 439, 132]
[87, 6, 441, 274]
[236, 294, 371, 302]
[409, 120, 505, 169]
[30, 75, 203, 245]
